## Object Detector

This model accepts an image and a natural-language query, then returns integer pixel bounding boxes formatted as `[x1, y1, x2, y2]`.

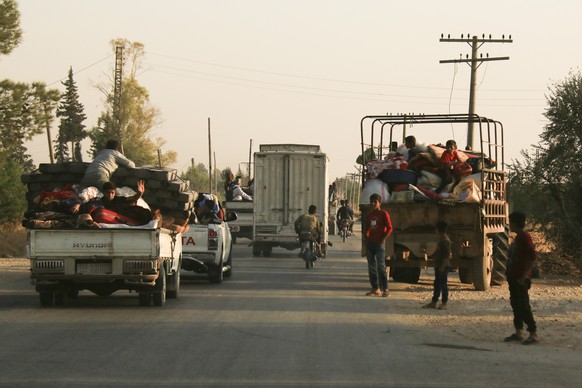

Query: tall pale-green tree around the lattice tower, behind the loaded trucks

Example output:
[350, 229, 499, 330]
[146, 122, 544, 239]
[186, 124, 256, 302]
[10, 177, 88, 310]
[89, 39, 176, 166]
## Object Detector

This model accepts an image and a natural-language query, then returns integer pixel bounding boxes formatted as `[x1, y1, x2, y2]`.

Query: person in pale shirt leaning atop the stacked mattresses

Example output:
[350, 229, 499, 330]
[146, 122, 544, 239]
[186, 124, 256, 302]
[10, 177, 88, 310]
[80, 140, 135, 188]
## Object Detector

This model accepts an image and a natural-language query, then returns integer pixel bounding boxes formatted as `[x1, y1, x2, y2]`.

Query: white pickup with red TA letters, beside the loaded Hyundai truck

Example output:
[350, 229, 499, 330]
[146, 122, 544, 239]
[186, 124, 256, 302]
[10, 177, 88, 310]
[182, 212, 237, 283]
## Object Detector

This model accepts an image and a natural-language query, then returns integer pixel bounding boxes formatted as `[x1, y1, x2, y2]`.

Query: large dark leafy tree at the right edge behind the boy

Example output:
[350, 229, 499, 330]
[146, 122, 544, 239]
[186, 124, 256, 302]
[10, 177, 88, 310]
[509, 71, 582, 254]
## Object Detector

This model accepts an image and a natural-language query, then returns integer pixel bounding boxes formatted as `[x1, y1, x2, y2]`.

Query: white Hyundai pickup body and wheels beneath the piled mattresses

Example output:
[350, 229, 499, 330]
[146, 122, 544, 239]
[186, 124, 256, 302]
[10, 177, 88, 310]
[27, 228, 182, 306]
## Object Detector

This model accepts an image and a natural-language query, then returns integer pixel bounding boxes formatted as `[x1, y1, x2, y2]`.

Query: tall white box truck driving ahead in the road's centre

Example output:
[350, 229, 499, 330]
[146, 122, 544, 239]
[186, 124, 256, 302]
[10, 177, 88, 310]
[253, 144, 329, 256]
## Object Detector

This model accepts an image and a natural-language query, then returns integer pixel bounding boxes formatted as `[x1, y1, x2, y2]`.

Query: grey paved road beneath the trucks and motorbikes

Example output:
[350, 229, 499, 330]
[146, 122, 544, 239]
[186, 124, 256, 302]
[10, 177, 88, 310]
[0, 232, 581, 387]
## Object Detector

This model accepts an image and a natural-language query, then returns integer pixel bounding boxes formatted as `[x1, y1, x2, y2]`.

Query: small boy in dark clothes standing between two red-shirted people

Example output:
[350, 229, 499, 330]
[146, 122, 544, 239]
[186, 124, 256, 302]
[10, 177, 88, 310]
[423, 221, 451, 310]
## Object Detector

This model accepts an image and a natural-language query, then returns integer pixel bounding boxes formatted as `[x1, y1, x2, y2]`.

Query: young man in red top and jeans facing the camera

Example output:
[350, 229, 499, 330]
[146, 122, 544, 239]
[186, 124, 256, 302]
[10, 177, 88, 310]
[365, 193, 392, 297]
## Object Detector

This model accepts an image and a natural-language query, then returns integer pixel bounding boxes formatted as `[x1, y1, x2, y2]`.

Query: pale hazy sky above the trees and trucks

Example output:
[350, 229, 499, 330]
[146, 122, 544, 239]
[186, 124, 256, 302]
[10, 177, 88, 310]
[0, 0, 582, 180]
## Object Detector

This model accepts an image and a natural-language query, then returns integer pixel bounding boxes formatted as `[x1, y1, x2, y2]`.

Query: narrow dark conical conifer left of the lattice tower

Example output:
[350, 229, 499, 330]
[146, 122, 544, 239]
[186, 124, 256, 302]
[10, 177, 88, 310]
[55, 67, 87, 162]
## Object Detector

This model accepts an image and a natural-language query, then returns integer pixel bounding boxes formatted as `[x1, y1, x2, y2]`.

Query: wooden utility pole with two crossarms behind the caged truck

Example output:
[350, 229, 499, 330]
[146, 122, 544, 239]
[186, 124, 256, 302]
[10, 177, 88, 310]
[439, 34, 513, 149]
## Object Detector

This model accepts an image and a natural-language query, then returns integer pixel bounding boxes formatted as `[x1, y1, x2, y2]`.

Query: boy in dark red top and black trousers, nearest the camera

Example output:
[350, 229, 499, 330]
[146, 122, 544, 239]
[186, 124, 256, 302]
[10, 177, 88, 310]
[504, 212, 540, 345]
